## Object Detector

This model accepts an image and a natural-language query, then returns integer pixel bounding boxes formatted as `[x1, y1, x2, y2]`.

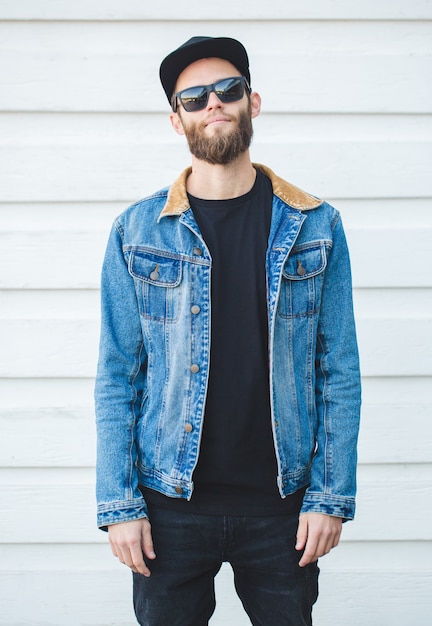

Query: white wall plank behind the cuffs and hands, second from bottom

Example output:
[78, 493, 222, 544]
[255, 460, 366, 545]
[0, 464, 432, 544]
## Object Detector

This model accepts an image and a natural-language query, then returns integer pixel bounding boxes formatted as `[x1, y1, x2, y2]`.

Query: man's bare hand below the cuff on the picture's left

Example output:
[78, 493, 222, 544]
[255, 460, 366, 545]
[108, 518, 156, 576]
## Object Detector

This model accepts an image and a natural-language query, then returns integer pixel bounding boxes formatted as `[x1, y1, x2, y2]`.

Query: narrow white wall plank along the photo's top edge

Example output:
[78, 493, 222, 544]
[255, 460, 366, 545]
[0, 0, 432, 20]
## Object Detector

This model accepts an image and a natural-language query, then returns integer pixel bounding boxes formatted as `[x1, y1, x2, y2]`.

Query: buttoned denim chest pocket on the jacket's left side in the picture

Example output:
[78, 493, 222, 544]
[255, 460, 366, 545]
[129, 250, 182, 322]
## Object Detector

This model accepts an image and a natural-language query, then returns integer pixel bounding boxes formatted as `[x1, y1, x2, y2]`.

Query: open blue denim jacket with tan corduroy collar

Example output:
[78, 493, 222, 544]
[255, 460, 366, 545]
[95, 165, 360, 527]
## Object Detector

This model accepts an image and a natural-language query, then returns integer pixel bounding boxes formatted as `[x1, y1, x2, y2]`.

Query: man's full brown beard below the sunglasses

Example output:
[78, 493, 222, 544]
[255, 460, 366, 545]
[179, 102, 253, 165]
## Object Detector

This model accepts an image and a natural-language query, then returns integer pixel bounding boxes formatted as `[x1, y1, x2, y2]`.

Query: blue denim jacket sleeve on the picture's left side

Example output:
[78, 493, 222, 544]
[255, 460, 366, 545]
[95, 222, 147, 530]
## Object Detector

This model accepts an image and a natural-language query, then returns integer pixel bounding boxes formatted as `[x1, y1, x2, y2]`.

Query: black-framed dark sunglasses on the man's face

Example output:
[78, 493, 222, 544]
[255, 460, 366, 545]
[172, 76, 251, 113]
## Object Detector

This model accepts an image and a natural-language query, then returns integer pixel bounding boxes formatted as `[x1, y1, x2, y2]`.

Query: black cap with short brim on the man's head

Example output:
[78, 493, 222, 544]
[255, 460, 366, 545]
[159, 37, 250, 104]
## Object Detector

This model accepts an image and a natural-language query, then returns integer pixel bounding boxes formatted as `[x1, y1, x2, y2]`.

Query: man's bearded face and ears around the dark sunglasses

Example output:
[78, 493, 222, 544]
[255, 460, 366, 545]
[171, 58, 259, 165]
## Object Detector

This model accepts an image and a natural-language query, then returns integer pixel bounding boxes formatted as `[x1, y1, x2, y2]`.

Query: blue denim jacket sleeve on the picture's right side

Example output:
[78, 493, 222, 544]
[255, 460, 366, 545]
[302, 213, 361, 520]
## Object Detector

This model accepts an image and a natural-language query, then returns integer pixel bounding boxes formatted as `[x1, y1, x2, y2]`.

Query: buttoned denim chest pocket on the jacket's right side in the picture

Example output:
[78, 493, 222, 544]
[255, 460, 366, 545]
[278, 242, 327, 317]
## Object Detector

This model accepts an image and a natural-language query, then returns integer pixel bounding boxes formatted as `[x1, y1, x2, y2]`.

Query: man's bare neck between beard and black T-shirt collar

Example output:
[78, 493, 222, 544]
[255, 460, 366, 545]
[186, 152, 256, 200]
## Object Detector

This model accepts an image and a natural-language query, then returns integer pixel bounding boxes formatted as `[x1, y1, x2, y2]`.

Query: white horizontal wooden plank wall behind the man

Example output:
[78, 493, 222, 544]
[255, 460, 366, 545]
[0, 0, 432, 626]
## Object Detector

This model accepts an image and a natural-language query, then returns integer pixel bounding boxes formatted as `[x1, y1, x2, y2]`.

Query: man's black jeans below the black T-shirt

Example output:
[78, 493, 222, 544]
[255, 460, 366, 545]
[133, 508, 319, 626]
